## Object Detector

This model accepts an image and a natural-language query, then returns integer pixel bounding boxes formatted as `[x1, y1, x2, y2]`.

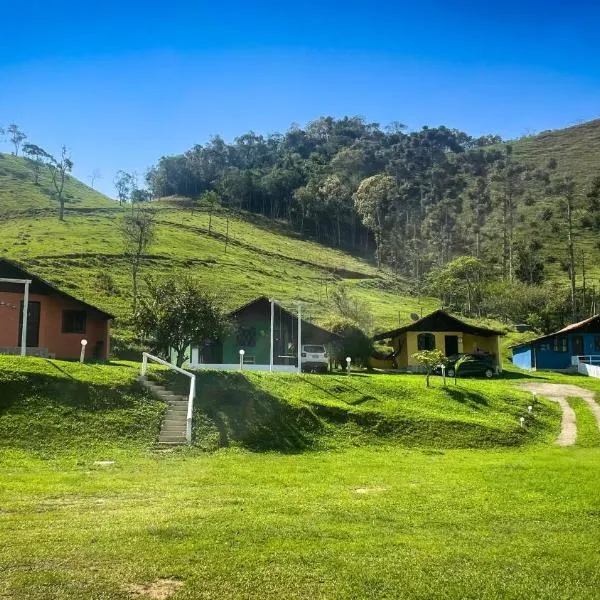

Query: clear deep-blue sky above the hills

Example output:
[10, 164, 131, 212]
[0, 0, 600, 194]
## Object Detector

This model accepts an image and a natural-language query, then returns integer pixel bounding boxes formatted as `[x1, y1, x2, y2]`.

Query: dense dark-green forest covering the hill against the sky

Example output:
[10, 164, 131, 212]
[147, 117, 600, 330]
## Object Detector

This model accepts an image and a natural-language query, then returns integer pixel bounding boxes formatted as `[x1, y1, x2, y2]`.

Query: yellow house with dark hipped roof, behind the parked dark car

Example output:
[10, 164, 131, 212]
[370, 310, 503, 371]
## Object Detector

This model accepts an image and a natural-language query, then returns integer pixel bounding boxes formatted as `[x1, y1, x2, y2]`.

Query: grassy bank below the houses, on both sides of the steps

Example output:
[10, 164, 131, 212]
[0, 357, 558, 455]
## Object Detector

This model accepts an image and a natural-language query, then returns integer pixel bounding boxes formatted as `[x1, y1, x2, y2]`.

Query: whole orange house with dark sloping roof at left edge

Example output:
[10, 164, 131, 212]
[0, 259, 113, 360]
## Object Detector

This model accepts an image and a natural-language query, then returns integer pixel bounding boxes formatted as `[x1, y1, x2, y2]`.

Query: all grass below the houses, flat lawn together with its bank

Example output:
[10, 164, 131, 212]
[0, 358, 600, 600]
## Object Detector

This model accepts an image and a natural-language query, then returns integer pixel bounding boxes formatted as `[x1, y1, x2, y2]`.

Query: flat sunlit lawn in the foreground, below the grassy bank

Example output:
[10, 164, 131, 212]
[0, 448, 600, 600]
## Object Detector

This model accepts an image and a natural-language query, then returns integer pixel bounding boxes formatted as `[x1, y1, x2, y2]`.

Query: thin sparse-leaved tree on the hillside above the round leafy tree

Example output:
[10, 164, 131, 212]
[120, 204, 156, 314]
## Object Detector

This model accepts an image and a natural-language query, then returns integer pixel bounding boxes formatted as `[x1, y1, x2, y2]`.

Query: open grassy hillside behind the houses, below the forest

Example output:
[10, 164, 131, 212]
[0, 155, 437, 342]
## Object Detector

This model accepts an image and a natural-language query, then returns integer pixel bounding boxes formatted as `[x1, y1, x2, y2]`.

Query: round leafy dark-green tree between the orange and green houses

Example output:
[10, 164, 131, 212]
[134, 277, 229, 367]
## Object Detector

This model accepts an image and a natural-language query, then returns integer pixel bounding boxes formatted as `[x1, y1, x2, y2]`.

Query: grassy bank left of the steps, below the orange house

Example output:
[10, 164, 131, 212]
[0, 357, 164, 456]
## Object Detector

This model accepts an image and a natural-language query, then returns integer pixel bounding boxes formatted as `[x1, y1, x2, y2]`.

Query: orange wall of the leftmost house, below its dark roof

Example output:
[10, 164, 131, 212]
[0, 292, 110, 359]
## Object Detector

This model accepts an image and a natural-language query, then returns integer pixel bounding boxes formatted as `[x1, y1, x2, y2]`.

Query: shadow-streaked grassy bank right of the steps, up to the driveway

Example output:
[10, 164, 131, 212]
[150, 372, 558, 451]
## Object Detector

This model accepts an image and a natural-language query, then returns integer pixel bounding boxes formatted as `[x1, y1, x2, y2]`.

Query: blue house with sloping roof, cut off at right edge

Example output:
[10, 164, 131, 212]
[512, 315, 600, 370]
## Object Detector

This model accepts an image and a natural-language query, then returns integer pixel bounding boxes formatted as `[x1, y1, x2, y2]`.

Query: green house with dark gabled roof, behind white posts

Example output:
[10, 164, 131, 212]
[178, 296, 336, 371]
